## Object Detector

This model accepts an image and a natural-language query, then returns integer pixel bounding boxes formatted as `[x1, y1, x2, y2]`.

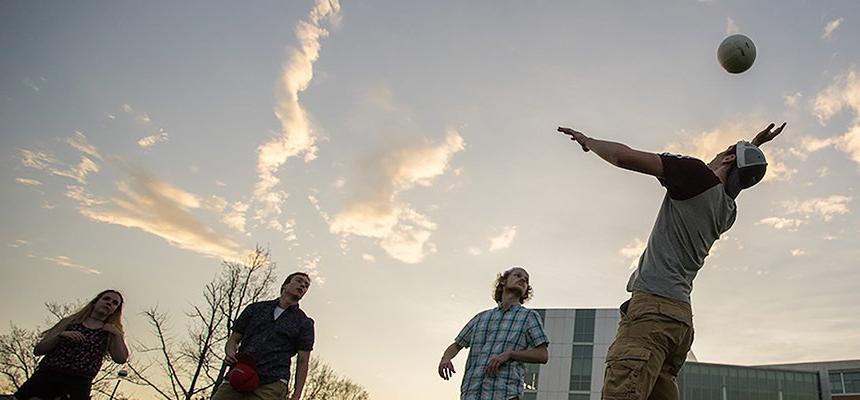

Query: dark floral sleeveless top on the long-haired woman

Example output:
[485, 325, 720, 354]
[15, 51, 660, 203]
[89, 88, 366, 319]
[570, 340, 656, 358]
[39, 324, 110, 379]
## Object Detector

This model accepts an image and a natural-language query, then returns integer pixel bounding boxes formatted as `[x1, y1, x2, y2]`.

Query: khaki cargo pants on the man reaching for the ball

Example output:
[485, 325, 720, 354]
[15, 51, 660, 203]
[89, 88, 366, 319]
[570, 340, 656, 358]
[602, 292, 693, 400]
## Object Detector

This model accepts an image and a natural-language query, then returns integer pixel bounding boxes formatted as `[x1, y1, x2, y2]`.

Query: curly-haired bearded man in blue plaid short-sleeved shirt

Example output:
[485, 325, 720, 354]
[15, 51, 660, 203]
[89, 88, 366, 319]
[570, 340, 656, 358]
[439, 267, 549, 400]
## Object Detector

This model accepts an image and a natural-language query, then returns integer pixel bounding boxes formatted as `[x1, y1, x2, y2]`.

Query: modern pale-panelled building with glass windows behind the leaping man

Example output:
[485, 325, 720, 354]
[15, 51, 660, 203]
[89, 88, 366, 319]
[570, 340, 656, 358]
[524, 308, 860, 400]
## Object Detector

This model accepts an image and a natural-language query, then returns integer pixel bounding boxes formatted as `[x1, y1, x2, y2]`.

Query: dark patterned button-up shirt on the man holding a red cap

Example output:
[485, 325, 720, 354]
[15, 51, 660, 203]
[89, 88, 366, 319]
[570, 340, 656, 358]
[233, 300, 314, 384]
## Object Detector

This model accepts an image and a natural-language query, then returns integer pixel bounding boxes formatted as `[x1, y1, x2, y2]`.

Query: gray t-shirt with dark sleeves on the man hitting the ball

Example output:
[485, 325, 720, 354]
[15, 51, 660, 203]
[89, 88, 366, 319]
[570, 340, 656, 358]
[627, 153, 736, 303]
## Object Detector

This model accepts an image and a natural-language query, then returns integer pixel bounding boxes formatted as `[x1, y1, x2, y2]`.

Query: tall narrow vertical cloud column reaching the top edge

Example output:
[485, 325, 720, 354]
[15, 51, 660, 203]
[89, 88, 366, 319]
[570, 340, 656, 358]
[254, 0, 340, 227]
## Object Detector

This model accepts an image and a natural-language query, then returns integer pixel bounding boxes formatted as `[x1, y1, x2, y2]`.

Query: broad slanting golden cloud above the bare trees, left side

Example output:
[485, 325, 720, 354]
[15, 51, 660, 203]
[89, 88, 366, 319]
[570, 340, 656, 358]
[66, 169, 239, 260]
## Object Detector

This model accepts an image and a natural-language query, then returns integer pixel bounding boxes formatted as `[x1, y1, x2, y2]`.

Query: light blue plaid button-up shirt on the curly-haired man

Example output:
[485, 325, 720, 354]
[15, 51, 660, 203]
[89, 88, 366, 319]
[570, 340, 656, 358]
[454, 304, 549, 400]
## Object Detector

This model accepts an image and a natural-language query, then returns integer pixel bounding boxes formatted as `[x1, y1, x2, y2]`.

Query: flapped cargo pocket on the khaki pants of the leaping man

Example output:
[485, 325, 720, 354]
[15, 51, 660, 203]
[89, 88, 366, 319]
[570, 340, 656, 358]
[603, 344, 651, 400]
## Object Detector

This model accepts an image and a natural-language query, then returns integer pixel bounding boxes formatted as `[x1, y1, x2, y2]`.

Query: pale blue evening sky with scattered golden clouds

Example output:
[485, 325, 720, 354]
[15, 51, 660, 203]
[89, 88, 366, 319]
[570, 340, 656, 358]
[0, 0, 860, 400]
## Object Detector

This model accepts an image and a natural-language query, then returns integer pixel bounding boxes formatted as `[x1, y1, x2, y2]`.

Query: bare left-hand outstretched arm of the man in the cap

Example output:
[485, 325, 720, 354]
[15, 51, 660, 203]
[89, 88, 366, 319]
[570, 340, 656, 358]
[558, 127, 663, 178]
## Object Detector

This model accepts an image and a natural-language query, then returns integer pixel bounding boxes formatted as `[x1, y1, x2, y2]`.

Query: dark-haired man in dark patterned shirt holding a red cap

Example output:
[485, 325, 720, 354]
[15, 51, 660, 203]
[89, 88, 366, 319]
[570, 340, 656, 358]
[212, 272, 314, 400]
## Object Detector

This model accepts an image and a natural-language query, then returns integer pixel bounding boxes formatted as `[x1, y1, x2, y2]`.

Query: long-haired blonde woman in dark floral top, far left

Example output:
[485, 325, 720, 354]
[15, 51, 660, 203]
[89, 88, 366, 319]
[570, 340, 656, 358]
[15, 290, 128, 400]
